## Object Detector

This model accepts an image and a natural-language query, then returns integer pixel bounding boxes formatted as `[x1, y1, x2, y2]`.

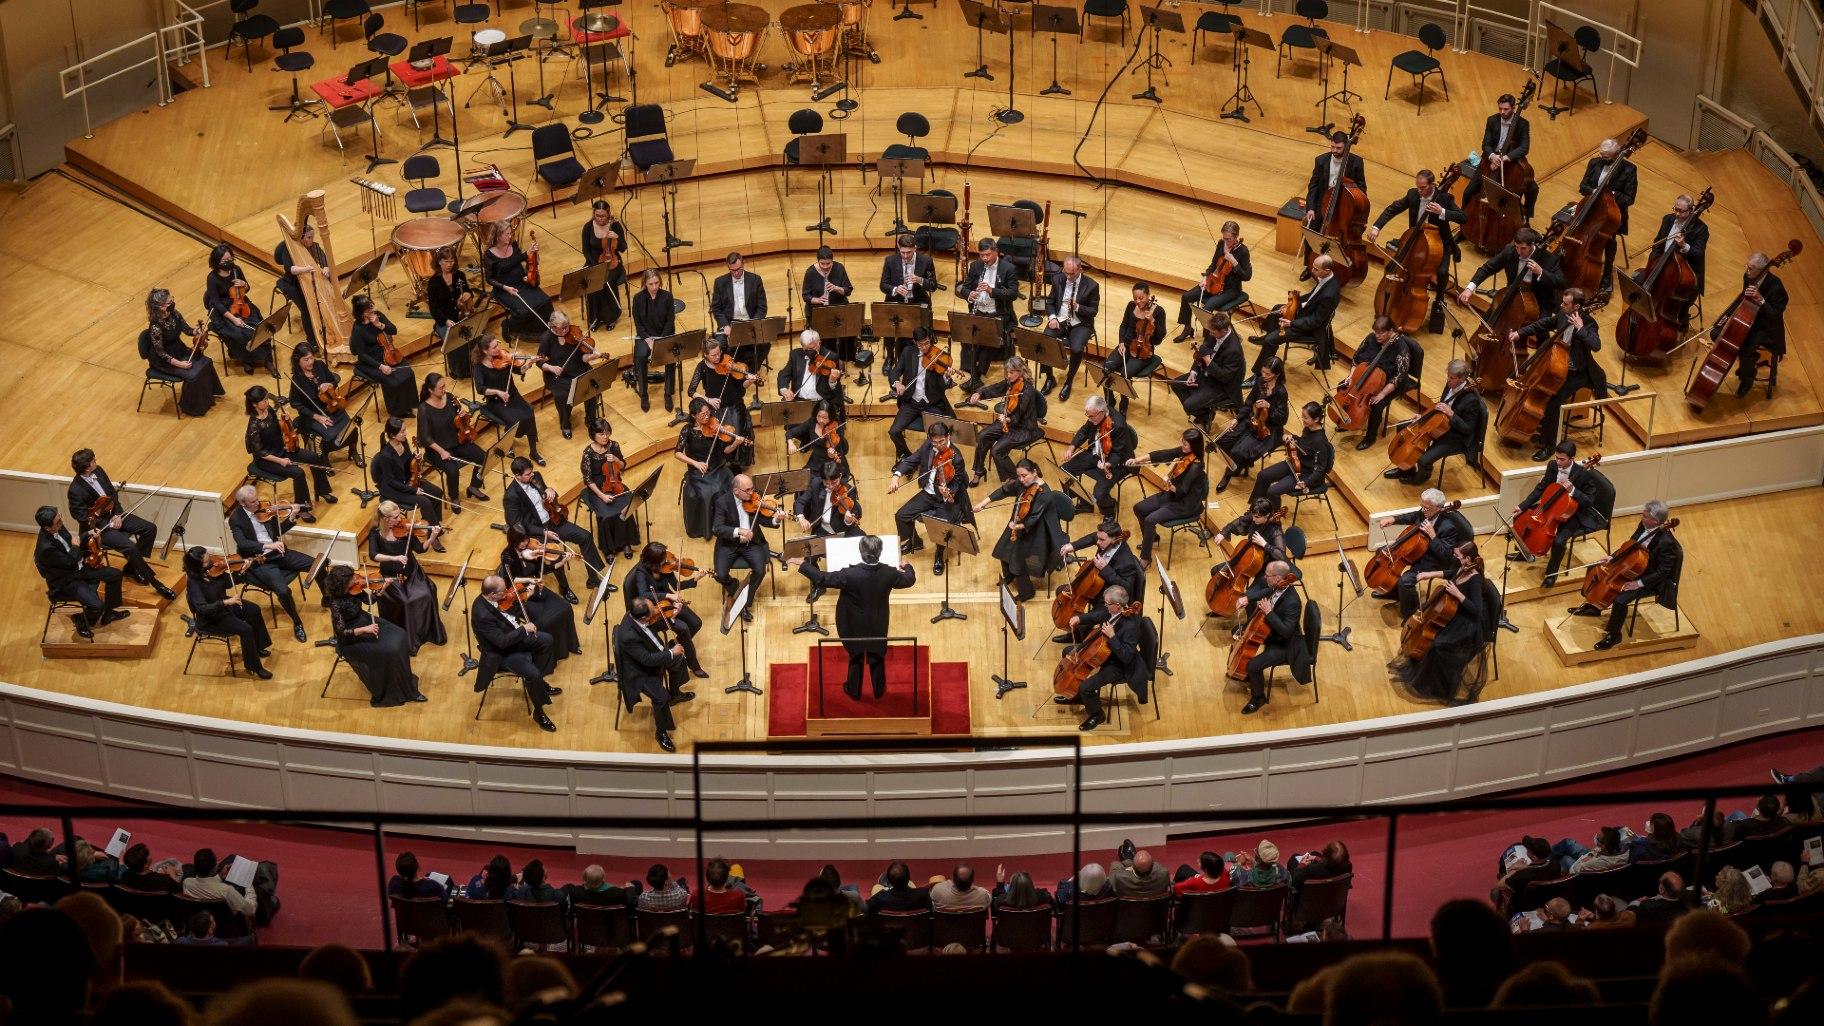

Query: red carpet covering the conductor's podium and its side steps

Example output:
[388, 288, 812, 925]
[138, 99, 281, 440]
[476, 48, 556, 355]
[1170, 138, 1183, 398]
[766, 644, 970, 738]
